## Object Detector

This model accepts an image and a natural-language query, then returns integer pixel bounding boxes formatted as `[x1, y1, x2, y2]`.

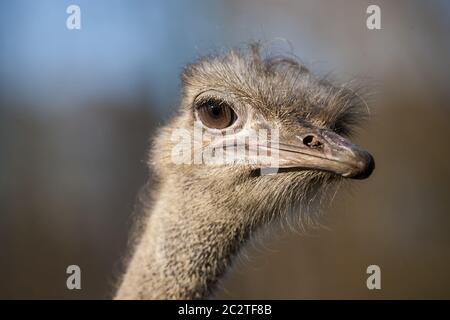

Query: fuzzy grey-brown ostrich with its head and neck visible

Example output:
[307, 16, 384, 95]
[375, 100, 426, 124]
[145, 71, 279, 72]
[115, 44, 374, 299]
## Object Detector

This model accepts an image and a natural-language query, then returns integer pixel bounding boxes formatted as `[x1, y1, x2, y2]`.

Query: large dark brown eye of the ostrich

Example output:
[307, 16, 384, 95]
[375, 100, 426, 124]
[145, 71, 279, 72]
[197, 100, 237, 129]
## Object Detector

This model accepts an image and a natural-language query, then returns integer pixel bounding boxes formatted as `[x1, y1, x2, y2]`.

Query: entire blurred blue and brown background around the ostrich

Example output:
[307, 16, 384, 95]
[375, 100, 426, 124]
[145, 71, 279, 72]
[0, 0, 450, 299]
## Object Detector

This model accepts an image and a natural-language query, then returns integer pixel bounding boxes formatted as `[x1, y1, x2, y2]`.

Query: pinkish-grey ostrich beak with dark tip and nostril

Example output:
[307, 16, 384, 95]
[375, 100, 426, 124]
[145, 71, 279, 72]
[272, 129, 375, 179]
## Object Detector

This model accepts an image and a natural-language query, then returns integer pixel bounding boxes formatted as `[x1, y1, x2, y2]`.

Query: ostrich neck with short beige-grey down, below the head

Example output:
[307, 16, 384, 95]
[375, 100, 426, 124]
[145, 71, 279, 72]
[116, 179, 248, 299]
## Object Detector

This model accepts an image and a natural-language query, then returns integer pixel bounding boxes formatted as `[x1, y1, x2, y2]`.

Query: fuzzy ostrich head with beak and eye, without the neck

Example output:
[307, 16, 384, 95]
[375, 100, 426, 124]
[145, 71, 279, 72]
[151, 45, 374, 230]
